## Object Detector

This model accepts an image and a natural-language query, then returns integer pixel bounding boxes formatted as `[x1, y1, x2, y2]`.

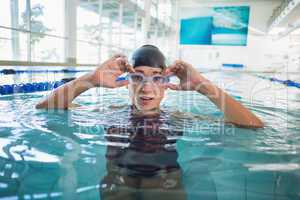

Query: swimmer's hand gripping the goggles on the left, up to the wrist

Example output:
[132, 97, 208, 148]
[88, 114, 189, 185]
[90, 54, 134, 88]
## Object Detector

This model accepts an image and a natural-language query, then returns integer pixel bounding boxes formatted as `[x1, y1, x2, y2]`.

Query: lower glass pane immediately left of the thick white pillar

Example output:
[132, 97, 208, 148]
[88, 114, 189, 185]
[31, 34, 65, 62]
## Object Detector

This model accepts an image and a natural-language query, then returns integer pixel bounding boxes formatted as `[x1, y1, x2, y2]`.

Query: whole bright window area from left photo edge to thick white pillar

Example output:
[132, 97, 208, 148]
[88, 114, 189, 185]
[0, 0, 64, 62]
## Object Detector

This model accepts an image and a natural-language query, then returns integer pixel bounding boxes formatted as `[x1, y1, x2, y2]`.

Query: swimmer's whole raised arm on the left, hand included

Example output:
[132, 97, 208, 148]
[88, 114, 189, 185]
[36, 55, 133, 109]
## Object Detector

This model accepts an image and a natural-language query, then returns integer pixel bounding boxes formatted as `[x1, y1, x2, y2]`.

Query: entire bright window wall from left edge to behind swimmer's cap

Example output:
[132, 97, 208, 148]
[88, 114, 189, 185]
[0, 0, 175, 64]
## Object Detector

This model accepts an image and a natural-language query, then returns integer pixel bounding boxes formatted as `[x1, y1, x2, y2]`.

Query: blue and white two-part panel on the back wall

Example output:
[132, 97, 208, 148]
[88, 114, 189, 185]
[180, 6, 250, 46]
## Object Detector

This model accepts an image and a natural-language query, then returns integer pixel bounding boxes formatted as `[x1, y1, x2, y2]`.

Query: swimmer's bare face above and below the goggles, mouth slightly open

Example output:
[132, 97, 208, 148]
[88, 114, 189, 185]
[129, 66, 166, 112]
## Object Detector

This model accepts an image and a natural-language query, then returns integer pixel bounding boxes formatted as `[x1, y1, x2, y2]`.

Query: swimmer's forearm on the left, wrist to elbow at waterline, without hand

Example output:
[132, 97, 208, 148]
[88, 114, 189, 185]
[36, 74, 94, 109]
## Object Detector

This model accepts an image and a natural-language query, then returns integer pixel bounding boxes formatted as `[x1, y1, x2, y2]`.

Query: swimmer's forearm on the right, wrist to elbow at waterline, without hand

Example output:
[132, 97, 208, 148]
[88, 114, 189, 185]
[198, 80, 264, 128]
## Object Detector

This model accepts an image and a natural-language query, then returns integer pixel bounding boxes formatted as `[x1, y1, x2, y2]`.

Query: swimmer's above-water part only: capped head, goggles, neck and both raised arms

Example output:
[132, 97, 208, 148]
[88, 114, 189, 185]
[36, 45, 264, 128]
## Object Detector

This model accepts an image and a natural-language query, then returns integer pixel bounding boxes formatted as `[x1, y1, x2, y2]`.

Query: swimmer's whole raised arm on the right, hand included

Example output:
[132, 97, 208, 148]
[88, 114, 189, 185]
[166, 61, 264, 128]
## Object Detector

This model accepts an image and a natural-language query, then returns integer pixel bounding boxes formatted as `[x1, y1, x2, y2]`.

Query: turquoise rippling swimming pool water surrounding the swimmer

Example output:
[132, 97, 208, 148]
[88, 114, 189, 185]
[0, 69, 300, 200]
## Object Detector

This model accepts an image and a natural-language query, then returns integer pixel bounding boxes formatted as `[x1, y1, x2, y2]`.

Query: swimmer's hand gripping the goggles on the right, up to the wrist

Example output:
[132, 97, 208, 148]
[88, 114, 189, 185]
[165, 60, 208, 91]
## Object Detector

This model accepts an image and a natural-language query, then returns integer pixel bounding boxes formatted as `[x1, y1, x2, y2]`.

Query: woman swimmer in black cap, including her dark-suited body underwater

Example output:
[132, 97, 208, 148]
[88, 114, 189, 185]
[36, 45, 264, 200]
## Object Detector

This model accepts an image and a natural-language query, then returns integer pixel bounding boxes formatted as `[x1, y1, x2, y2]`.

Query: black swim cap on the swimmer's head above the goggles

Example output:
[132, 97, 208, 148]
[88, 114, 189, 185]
[131, 45, 166, 69]
